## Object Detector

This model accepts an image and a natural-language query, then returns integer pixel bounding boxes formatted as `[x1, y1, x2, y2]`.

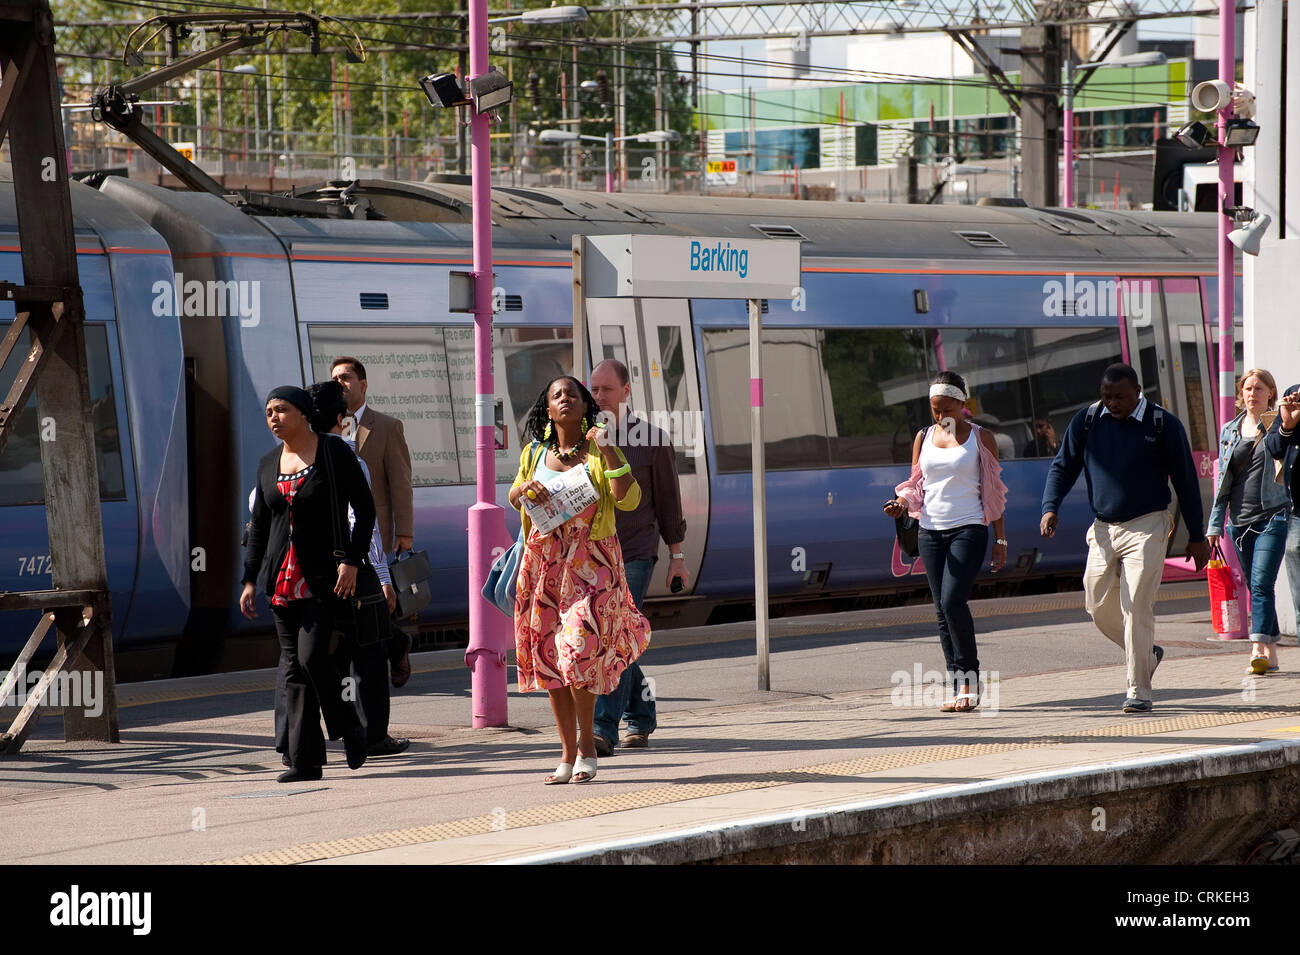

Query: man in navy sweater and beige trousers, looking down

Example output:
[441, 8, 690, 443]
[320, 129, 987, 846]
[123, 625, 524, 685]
[1039, 364, 1209, 713]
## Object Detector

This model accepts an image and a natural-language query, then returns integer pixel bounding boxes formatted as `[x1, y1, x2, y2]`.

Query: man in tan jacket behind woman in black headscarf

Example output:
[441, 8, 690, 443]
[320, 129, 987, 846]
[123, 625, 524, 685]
[330, 355, 415, 686]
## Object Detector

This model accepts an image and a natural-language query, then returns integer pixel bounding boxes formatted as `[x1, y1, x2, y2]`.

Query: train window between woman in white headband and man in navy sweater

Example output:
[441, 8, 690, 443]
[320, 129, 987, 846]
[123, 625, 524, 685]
[1018, 326, 1122, 457]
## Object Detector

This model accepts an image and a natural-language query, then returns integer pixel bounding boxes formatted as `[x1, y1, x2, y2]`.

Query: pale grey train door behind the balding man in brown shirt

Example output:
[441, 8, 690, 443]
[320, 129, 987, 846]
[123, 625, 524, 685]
[588, 299, 709, 596]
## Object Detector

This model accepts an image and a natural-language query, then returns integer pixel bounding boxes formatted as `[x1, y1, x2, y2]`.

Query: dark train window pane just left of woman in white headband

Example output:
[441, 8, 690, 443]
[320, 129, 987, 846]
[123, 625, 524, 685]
[822, 329, 931, 468]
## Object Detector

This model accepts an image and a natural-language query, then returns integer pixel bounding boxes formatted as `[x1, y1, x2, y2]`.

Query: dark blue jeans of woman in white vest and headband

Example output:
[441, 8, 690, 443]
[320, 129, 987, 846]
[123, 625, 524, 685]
[918, 524, 988, 691]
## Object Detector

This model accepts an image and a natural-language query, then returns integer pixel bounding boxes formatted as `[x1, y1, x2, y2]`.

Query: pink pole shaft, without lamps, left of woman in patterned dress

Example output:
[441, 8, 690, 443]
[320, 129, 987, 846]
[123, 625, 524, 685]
[465, 0, 512, 729]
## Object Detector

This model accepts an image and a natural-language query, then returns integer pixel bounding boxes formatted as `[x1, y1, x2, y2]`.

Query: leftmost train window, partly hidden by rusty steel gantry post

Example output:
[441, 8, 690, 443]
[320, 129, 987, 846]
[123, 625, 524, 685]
[0, 324, 126, 507]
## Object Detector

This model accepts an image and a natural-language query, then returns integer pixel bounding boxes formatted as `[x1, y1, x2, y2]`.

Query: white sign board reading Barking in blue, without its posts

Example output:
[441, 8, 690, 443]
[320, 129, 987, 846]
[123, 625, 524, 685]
[584, 235, 802, 300]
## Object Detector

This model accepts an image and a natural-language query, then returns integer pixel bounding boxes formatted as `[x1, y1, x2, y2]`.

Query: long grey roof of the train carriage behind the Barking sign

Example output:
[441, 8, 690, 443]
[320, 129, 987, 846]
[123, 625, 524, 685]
[276, 179, 1218, 264]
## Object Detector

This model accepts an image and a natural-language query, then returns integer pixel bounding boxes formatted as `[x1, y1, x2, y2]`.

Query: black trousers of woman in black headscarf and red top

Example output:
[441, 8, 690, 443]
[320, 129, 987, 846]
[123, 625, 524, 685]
[272, 598, 361, 768]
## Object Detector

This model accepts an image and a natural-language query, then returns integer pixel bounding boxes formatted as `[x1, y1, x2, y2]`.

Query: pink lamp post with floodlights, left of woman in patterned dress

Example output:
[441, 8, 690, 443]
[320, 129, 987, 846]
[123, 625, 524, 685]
[420, 0, 586, 729]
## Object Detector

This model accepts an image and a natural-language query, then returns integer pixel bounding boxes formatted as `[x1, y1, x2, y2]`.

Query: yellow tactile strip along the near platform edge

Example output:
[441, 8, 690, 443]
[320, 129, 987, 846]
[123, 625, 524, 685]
[208, 707, 1300, 865]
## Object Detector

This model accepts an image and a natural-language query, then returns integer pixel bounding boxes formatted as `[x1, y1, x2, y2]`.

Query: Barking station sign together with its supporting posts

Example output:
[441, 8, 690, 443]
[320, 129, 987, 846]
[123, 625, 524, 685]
[573, 235, 802, 690]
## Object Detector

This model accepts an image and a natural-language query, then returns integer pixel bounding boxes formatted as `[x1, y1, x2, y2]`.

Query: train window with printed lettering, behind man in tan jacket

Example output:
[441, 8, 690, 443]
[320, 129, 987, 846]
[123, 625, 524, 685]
[308, 325, 573, 487]
